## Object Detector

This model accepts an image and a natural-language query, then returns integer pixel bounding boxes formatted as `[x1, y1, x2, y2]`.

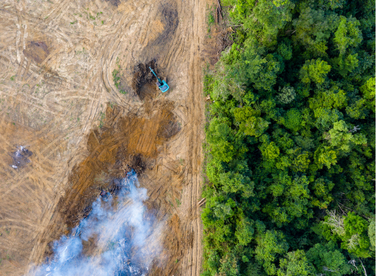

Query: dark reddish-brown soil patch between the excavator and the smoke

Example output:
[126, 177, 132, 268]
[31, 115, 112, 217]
[40, 98, 178, 245]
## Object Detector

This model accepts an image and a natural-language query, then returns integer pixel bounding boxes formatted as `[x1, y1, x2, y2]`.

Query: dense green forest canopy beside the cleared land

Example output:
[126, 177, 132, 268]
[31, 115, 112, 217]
[202, 0, 375, 276]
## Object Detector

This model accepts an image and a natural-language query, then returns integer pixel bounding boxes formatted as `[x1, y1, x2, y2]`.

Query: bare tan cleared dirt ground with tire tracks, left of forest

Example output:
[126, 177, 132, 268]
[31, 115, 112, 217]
[0, 0, 210, 275]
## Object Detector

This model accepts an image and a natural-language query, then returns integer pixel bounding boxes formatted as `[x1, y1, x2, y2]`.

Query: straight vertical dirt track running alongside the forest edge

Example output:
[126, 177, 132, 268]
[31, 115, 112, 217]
[183, 0, 205, 276]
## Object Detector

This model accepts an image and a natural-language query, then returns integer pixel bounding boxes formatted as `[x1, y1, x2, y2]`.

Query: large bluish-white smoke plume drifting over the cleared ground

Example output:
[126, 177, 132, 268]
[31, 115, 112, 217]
[30, 171, 162, 276]
